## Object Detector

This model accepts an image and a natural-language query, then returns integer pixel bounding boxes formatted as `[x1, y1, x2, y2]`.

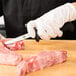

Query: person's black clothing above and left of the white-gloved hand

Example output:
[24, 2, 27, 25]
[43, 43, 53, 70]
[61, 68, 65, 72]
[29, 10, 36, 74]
[0, 0, 76, 37]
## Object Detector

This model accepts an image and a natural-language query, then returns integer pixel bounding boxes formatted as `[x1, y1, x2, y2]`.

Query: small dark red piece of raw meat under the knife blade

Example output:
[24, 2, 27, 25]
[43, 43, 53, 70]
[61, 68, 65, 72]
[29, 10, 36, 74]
[1, 39, 24, 51]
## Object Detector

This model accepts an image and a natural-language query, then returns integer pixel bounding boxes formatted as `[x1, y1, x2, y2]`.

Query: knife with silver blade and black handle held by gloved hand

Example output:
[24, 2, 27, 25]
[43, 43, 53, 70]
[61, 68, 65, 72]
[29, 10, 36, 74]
[5, 29, 40, 45]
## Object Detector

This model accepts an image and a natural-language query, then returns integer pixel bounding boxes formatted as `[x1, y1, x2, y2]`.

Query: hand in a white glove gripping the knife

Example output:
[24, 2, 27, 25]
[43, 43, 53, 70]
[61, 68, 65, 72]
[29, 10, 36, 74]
[27, 3, 76, 40]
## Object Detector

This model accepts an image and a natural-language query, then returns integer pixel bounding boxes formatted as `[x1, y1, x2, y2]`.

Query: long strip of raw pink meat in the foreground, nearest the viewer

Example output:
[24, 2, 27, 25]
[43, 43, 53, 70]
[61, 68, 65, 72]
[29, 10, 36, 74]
[17, 51, 67, 76]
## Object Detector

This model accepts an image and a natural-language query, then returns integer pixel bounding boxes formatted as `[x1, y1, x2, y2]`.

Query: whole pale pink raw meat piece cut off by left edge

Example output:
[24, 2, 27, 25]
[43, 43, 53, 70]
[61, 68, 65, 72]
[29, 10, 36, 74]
[0, 39, 23, 65]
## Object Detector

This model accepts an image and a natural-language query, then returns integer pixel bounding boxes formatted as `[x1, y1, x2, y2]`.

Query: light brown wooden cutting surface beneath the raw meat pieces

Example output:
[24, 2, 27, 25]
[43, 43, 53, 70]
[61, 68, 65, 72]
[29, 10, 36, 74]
[0, 40, 76, 76]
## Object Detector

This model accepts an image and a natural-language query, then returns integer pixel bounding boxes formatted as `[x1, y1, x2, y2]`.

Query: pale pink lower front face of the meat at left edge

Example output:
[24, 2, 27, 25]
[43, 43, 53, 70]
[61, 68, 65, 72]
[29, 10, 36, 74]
[0, 52, 23, 65]
